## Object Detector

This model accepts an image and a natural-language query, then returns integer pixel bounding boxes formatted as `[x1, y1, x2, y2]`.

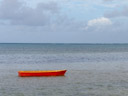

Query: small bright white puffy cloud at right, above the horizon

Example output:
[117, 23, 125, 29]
[85, 17, 112, 30]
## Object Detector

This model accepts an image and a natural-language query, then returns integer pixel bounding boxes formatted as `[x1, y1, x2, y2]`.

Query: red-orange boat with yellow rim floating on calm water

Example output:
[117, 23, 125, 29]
[18, 70, 67, 77]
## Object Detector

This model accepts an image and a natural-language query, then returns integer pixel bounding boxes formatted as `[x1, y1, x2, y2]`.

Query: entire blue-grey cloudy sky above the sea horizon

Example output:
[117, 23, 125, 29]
[0, 0, 128, 43]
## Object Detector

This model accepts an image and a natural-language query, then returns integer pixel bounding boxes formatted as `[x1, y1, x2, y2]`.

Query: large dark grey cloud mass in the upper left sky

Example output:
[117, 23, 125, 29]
[0, 0, 59, 26]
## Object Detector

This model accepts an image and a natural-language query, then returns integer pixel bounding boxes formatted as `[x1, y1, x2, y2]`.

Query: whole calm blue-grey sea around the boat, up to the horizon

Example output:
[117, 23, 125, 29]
[0, 43, 128, 96]
